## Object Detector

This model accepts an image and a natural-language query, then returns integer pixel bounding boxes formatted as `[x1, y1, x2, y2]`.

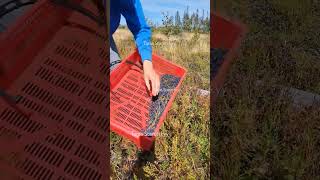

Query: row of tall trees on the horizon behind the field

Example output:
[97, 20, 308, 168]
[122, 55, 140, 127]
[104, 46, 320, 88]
[156, 7, 210, 35]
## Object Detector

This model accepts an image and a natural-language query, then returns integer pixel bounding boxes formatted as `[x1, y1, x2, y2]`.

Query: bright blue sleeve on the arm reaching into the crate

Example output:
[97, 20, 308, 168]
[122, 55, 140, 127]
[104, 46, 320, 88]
[121, 0, 152, 62]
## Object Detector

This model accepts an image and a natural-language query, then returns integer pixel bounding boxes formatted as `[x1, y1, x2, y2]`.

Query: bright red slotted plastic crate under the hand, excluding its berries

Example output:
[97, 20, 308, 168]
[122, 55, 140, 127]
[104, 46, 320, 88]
[110, 51, 186, 150]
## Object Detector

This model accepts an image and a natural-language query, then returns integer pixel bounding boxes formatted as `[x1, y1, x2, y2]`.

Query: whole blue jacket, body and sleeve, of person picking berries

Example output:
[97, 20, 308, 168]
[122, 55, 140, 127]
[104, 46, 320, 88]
[104, 0, 152, 62]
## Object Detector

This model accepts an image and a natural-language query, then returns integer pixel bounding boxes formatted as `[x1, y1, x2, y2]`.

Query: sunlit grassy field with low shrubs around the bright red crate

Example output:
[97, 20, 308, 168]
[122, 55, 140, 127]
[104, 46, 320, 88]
[110, 29, 210, 179]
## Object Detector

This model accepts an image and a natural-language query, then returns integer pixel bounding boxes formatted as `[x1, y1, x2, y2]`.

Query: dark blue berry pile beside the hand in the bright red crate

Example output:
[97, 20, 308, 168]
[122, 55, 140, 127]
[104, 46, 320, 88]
[144, 74, 180, 136]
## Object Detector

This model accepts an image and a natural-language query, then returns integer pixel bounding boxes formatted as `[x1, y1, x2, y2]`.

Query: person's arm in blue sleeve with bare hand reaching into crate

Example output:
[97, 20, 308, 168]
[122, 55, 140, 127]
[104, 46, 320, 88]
[121, 0, 160, 96]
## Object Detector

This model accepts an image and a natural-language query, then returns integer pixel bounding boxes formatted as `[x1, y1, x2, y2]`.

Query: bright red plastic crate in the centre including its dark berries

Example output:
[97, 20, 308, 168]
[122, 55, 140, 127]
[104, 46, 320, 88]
[110, 51, 186, 150]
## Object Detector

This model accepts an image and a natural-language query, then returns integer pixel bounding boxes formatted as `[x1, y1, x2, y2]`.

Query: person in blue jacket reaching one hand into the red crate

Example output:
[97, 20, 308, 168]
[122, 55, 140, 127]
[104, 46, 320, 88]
[109, 0, 160, 96]
